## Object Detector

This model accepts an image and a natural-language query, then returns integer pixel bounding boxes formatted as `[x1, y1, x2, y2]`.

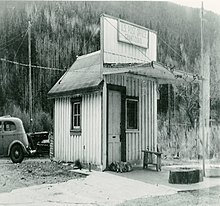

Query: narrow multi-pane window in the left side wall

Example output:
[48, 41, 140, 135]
[71, 101, 81, 131]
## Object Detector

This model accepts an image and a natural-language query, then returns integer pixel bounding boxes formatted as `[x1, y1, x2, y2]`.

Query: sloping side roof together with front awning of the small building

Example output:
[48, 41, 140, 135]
[48, 51, 198, 97]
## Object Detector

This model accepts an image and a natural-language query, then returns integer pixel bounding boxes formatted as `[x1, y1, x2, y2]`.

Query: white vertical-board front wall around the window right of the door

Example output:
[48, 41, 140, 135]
[106, 74, 157, 161]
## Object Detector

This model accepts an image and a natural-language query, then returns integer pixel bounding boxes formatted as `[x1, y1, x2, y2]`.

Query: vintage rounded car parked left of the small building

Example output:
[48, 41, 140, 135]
[0, 116, 48, 163]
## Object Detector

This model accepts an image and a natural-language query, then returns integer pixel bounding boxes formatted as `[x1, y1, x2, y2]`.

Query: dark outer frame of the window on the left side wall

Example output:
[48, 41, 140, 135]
[70, 98, 82, 135]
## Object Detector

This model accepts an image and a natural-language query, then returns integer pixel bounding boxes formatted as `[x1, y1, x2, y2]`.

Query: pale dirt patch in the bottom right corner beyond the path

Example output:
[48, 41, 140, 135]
[118, 186, 220, 206]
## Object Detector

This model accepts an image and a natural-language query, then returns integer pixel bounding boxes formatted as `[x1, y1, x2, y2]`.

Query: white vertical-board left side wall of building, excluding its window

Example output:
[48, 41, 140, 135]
[54, 92, 101, 165]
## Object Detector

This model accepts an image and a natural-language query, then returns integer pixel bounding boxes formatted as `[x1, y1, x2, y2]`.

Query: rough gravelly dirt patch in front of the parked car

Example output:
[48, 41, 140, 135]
[0, 158, 85, 193]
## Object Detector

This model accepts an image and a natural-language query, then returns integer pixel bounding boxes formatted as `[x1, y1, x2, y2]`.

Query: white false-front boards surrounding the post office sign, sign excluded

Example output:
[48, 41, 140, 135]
[103, 17, 157, 63]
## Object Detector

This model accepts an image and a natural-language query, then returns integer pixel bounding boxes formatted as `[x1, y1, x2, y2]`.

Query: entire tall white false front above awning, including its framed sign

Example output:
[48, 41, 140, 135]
[101, 15, 157, 63]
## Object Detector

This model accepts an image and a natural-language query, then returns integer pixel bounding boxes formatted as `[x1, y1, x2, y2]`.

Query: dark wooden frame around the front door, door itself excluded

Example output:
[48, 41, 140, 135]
[106, 84, 126, 166]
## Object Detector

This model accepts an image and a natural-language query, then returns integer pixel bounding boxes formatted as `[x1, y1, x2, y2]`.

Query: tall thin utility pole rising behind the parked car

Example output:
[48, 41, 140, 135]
[28, 20, 33, 132]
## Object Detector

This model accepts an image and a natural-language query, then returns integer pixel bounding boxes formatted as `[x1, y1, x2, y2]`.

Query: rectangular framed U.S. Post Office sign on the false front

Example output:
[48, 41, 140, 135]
[118, 20, 149, 49]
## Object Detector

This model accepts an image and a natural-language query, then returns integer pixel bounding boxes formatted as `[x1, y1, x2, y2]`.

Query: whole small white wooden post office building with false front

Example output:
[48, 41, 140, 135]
[49, 15, 174, 169]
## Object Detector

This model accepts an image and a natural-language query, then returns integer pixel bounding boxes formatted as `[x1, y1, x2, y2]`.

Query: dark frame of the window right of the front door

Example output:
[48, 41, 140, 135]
[125, 96, 139, 131]
